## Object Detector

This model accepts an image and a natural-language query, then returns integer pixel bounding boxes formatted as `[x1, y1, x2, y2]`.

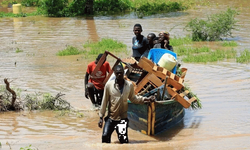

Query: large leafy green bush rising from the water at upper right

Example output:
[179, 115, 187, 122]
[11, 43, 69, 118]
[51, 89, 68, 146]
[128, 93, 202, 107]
[186, 8, 238, 41]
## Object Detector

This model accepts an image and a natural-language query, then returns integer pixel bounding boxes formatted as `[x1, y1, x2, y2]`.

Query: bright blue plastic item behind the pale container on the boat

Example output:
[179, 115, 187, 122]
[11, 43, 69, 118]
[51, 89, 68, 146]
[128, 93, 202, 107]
[148, 48, 177, 74]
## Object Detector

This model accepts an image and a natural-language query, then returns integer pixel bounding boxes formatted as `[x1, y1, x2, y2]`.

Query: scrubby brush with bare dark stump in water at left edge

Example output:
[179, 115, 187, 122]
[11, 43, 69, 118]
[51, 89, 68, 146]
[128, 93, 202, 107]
[0, 79, 83, 117]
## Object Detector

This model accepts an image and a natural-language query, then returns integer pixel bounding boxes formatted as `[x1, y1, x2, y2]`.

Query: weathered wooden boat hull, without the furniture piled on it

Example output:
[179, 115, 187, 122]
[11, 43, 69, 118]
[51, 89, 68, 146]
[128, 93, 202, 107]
[128, 100, 185, 135]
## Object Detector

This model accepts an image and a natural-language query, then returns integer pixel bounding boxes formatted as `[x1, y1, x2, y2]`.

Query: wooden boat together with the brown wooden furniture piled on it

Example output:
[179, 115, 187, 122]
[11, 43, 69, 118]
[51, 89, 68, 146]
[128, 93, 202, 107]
[92, 51, 196, 135]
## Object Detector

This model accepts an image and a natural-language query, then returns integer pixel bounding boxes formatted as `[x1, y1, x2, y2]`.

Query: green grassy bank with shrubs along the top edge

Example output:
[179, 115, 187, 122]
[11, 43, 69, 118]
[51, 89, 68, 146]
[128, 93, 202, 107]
[0, 0, 205, 18]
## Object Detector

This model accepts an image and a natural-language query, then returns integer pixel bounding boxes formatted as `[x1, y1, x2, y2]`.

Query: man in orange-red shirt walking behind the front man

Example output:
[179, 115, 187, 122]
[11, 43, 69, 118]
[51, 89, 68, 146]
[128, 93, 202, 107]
[85, 54, 111, 107]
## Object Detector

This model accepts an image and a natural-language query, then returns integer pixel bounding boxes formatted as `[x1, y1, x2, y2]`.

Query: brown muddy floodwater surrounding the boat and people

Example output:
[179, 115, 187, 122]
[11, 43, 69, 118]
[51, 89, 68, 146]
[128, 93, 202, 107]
[0, 0, 250, 150]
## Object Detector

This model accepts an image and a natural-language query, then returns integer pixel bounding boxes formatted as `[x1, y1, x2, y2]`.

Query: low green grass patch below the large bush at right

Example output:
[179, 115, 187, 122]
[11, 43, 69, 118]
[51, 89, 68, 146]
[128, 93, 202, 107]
[170, 37, 250, 63]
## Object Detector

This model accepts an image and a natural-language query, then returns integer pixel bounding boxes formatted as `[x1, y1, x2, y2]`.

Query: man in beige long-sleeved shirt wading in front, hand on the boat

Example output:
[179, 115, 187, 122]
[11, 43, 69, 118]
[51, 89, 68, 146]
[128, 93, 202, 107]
[98, 65, 155, 143]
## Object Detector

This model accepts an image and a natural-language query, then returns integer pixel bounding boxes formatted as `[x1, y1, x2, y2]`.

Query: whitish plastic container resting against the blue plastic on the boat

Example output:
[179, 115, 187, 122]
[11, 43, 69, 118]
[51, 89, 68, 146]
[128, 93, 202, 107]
[158, 53, 177, 71]
